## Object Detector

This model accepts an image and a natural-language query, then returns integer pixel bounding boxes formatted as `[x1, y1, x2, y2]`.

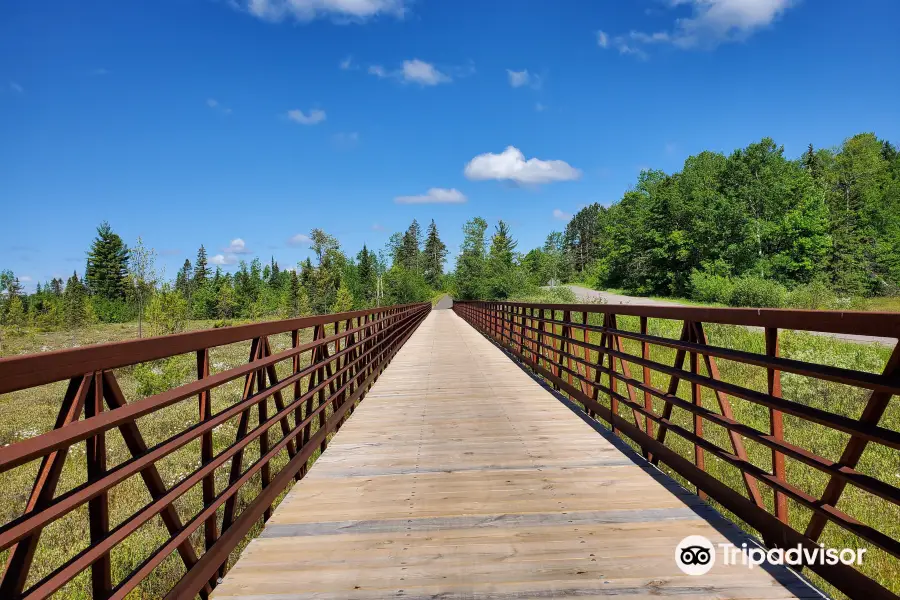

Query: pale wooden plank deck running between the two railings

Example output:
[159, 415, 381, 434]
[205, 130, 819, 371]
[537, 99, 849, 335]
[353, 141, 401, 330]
[213, 310, 821, 600]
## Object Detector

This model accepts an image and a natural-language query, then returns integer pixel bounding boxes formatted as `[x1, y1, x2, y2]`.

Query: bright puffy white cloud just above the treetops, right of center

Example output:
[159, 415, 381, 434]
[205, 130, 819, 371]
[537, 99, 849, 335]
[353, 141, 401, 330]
[465, 146, 581, 184]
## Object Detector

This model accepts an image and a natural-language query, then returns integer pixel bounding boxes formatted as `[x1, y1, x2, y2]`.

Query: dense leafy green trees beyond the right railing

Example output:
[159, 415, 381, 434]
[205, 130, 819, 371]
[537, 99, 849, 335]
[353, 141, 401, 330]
[456, 133, 900, 308]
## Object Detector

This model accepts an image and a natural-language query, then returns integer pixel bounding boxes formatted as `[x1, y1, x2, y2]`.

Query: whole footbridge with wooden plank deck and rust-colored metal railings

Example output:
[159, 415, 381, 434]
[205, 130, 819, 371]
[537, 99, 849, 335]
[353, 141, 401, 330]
[0, 302, 900, 600]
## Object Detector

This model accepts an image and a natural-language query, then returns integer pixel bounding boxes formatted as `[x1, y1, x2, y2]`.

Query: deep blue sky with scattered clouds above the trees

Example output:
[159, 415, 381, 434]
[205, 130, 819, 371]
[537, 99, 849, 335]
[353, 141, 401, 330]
[0, 0, 900, 287]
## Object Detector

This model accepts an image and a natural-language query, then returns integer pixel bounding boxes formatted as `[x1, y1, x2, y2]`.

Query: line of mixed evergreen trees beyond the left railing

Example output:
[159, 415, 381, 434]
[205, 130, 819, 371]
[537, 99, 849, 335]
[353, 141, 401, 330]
[0, 221, 447, 336]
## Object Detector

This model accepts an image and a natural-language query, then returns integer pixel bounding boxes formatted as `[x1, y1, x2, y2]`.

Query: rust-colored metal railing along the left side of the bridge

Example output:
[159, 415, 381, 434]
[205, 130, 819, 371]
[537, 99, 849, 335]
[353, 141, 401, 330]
[0, 304, 431, 600]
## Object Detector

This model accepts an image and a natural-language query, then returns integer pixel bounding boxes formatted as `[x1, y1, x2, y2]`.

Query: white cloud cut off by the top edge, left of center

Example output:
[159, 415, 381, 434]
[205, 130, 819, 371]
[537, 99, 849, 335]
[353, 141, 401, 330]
[239, 0, 408, 23]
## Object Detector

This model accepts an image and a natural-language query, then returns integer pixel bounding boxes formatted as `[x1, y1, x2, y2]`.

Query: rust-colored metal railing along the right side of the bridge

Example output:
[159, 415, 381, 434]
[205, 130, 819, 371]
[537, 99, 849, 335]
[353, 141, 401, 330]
[453, 302, 900, 598]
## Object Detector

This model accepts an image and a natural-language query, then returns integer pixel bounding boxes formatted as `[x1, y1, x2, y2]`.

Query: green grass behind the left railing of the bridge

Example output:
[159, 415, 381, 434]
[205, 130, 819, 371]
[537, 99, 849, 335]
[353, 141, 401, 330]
[0, 321, 362, 599]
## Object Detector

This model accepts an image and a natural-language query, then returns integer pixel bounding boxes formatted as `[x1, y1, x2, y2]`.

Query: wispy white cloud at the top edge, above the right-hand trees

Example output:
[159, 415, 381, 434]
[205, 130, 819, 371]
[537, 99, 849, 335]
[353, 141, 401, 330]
[597, 0, 799, 58]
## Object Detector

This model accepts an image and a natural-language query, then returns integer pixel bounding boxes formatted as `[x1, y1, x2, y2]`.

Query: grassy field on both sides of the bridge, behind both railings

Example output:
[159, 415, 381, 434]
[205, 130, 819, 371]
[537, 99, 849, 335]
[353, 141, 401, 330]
[0, 315, 900, 599]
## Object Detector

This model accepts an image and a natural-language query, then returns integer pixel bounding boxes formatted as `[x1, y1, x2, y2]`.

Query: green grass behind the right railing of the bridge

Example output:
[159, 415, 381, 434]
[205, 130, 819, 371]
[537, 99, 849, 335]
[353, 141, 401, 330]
[506, 312, 900, 596]
